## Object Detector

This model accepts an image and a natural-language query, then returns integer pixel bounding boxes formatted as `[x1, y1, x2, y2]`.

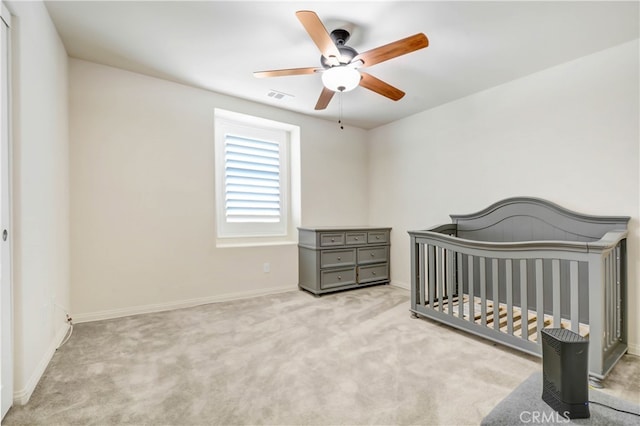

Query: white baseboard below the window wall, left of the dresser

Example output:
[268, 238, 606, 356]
[73, 285, 298, 324]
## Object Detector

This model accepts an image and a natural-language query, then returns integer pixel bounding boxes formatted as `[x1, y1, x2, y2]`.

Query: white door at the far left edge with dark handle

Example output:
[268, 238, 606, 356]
[0, 0, 13, 419]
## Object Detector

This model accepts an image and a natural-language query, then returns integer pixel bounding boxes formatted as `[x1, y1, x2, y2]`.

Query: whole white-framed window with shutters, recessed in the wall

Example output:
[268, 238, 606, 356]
[215, 109, 300, 245]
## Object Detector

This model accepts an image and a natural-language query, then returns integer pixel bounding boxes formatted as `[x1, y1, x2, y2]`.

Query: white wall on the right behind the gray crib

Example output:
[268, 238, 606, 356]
[369, 40, 640, 353]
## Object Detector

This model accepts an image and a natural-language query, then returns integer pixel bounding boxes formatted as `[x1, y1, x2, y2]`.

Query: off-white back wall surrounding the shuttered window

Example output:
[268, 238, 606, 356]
[69, 59, 368, 320]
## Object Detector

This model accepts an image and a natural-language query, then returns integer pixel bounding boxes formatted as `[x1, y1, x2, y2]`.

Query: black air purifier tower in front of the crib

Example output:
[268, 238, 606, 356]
[541, 328, 589, 419]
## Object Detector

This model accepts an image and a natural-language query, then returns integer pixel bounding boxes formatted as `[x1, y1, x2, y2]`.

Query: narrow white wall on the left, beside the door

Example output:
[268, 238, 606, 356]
[8, 1, 69, 403]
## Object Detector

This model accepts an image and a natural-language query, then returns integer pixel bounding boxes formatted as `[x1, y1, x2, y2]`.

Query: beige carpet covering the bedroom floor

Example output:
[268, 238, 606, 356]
[3, 286, 640, 426]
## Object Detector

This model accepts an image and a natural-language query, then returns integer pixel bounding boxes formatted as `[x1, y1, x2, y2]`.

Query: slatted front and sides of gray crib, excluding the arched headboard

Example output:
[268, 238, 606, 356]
[409, 224, 627, 379]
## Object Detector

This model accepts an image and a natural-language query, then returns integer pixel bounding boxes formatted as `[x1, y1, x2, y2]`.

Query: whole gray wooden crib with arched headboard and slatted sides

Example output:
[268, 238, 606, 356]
[409, 197, 629, 385]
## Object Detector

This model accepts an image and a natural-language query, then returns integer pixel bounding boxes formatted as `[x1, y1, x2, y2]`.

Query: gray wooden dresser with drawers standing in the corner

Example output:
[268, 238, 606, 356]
[298, 227, 391, 295]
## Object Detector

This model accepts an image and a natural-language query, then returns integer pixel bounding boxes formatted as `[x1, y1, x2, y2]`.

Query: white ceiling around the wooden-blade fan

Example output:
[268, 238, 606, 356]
[47, 1, 640, 128]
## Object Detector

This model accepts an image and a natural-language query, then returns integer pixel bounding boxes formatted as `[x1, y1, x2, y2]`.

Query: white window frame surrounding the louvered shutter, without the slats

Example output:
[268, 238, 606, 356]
[214, 108, 300, 247]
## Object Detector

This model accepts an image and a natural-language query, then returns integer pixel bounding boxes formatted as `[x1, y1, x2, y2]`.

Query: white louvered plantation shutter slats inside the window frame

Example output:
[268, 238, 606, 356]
[224, 134, 282, 223]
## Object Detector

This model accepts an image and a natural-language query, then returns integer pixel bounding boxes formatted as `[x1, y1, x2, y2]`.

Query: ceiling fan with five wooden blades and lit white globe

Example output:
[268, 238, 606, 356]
[253, 10, 429, 110]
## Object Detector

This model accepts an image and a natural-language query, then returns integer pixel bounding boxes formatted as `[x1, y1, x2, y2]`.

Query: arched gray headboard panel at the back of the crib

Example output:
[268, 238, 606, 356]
[451, 197, 630, 242]
